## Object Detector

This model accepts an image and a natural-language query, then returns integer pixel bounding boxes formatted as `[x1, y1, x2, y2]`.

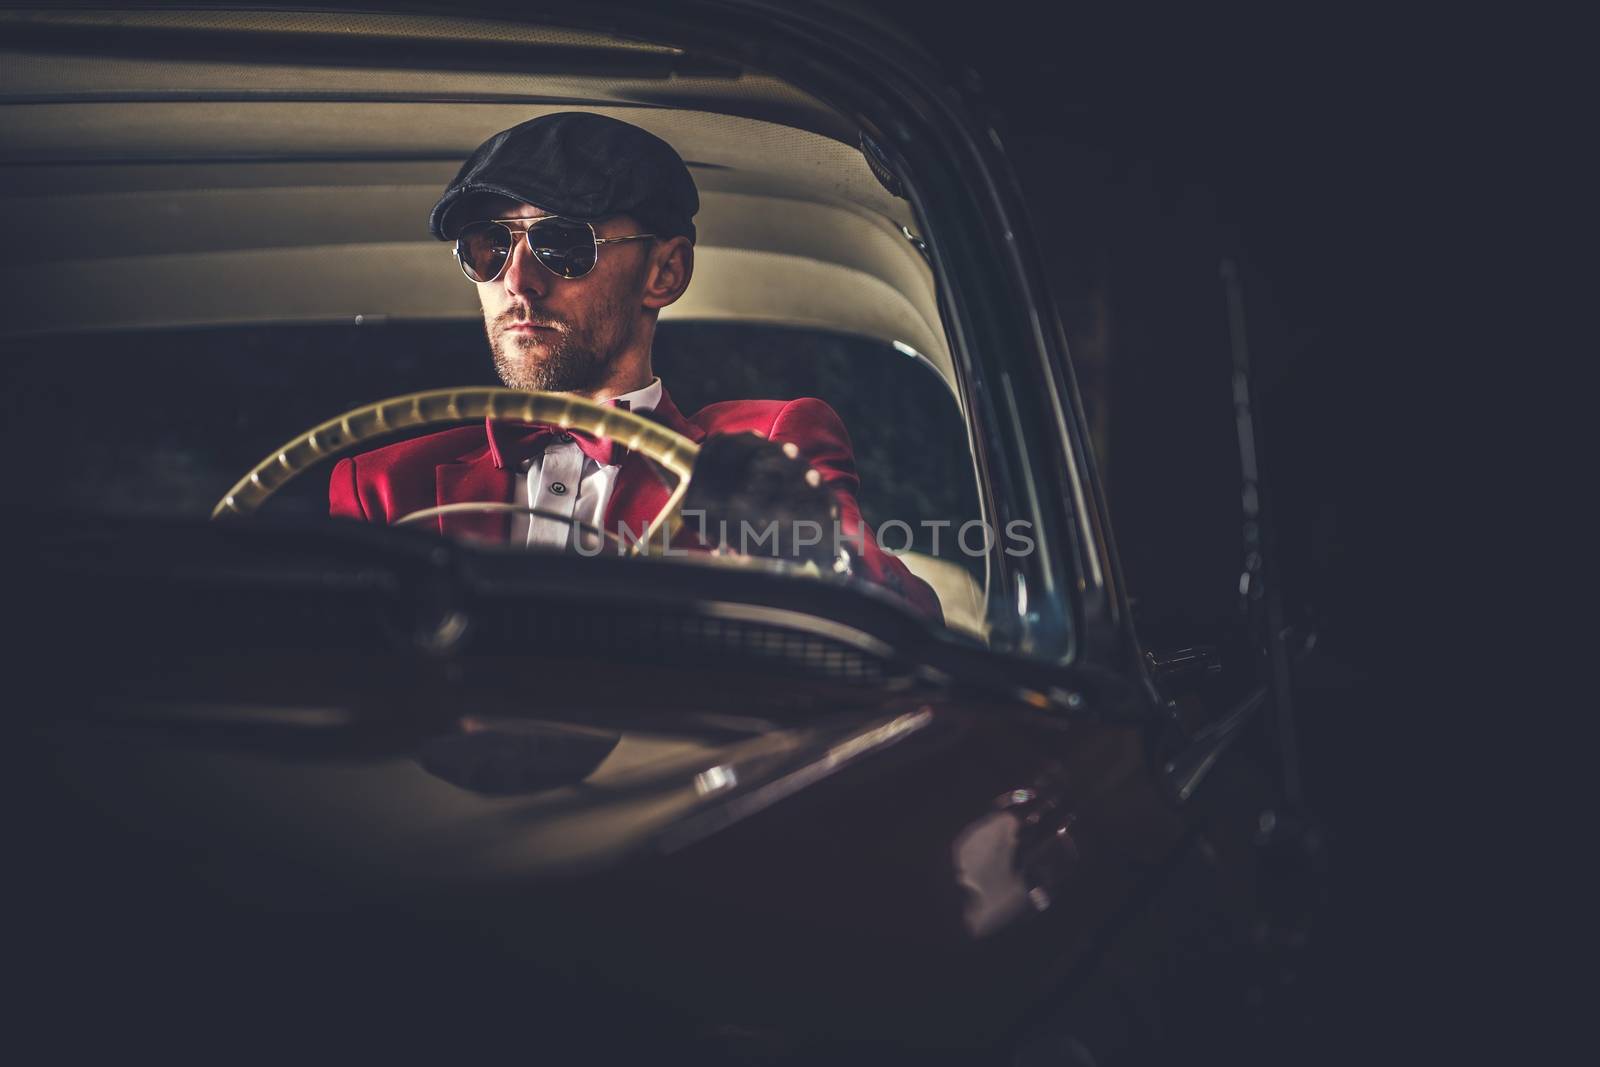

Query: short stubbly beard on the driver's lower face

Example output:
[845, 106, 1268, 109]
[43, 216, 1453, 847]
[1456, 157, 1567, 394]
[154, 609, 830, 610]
[485, 292, 630, 392]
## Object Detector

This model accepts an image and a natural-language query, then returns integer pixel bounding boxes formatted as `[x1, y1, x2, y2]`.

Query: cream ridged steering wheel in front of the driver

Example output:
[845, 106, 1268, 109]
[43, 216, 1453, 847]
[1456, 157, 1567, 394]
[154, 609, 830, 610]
[211, 386, 699, 553]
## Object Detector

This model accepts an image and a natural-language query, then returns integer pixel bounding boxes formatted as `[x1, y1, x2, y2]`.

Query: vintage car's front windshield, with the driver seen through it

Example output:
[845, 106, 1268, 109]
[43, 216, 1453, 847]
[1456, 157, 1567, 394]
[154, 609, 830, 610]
[0, 13, 1075, 652]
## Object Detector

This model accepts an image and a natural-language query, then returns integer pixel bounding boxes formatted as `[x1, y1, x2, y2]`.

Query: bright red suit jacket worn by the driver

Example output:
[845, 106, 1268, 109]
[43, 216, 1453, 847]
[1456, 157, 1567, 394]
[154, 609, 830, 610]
[328, 389, 944, 621]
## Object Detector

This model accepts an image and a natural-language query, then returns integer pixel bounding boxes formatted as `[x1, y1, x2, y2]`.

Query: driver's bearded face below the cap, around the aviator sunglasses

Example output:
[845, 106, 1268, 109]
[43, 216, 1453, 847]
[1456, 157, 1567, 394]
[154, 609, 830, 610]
[472, 198, 651, 392]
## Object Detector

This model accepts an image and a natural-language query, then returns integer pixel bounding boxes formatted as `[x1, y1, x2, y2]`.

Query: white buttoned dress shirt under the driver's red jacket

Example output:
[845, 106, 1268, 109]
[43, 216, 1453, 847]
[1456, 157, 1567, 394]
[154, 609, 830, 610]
[510, 378, 661, 549]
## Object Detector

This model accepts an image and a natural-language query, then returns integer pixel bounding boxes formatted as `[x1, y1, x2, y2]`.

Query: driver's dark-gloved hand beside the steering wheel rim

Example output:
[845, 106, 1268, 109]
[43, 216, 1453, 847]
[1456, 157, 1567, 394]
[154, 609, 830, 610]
[683, 434, 837, 568]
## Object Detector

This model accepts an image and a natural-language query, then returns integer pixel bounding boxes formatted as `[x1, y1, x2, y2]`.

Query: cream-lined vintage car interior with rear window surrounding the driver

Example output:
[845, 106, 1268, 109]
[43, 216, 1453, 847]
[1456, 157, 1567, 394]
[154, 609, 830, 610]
[0, 10, 990, 640]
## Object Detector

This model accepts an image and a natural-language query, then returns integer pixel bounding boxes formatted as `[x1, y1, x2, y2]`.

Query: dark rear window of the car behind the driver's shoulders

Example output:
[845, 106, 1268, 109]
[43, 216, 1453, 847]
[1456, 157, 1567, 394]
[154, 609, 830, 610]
[0, 322, 984, 629]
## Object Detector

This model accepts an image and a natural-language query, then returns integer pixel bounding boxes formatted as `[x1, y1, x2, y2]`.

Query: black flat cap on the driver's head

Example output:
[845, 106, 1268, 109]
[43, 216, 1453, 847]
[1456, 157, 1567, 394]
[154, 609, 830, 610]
[427, 110, 699, 242]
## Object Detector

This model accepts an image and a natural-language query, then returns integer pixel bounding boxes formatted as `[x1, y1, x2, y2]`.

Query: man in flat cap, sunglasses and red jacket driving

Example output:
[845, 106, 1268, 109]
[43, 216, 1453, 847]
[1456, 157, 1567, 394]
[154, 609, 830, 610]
[328, 112, 942, 619]
